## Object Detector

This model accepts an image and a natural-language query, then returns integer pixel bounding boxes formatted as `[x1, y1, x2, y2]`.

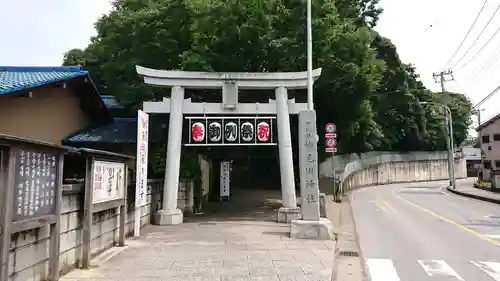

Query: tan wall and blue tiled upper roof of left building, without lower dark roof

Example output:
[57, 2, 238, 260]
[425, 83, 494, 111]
[0, 66, 113, 144]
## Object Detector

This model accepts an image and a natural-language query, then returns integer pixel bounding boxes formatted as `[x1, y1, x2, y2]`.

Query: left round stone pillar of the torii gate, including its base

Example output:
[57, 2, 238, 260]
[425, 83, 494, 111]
[155, 86, 184, 225]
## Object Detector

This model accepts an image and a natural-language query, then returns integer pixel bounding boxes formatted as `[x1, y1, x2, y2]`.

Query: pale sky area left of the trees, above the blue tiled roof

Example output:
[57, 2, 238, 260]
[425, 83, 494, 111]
[0, 0, 111, 66]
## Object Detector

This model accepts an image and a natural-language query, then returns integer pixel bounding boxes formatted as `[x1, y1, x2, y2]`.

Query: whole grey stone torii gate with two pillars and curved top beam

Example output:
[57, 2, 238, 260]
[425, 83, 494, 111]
[136, 66, 321, 225]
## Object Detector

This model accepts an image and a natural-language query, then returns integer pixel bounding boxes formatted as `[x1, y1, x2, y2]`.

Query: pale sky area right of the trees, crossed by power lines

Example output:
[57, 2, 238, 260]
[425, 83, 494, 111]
[376, 0, 500, 127]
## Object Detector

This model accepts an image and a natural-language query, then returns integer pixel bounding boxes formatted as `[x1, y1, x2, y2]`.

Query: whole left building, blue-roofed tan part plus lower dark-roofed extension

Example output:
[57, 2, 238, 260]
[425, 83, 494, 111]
[0, 66, 168, 154]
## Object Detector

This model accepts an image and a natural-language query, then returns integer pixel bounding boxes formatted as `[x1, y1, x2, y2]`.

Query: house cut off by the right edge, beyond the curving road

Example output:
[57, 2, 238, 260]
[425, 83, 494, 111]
[476, 114, 500, 180]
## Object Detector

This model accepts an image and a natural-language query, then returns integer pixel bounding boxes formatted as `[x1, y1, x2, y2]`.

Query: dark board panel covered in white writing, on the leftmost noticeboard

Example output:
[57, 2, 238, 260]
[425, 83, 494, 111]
[11, 147, 59, 222]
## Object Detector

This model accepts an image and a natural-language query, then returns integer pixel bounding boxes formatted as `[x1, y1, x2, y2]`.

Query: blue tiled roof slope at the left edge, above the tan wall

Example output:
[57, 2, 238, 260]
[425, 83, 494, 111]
[0, 66, 89, 95]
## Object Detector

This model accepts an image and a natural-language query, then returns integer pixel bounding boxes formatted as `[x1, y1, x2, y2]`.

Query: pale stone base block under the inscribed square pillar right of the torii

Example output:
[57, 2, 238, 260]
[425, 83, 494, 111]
[290, 218, 334, 240]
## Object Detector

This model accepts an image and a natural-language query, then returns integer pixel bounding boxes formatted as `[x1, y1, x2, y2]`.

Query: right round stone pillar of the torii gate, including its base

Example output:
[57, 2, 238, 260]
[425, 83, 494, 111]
[276, 87, 300, 223]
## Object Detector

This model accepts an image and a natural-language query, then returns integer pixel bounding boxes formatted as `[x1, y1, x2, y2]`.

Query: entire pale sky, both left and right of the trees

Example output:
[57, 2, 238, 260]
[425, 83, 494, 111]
[0, 0, 500, 129]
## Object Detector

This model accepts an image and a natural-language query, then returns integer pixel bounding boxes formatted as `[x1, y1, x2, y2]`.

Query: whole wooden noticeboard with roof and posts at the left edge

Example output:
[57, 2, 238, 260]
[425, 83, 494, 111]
[0, 134, 68, 281]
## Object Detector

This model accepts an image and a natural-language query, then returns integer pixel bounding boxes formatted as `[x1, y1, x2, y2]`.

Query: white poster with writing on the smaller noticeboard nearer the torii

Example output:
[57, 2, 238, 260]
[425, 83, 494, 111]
[92, 161, 125, 204]
